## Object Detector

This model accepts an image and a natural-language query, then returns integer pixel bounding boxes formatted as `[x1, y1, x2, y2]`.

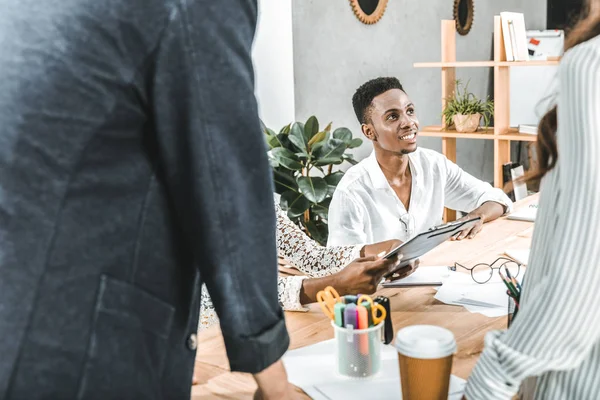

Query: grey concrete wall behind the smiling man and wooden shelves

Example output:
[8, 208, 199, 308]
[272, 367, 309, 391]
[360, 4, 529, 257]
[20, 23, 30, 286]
[292, 0, 546, 181]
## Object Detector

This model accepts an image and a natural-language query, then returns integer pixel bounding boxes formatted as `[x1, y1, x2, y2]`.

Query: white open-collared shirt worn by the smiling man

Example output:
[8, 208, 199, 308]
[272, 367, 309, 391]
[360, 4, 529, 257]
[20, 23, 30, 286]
[327, 148, 512, 246]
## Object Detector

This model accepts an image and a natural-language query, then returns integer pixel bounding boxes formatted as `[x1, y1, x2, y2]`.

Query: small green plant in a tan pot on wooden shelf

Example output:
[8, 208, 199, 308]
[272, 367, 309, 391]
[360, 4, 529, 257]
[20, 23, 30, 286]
[442, 80, 494, 133]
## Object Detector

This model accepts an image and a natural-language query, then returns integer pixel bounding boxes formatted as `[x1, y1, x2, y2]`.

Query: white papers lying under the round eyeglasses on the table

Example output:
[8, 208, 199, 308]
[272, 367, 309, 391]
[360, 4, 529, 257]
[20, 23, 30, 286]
[434, 268, 524, 317]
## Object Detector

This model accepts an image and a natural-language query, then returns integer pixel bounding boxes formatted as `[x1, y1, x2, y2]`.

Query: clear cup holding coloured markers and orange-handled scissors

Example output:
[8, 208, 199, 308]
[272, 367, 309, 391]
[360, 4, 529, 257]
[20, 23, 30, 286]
[331, 322, 384, 379]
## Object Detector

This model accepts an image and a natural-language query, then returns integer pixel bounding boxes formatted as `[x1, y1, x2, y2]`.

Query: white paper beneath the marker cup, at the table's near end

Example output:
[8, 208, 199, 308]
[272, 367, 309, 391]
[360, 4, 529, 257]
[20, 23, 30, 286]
[283, 340, 466, 400]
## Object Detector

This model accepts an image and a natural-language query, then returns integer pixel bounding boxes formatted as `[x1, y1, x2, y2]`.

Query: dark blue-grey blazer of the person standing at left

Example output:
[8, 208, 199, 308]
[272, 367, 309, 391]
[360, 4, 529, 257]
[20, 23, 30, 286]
[0, 0, 288, 399]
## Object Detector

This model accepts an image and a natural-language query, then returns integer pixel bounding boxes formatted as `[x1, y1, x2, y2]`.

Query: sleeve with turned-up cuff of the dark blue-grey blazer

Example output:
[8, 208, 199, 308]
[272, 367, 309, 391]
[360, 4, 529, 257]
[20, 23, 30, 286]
[150, 0, 289, 373]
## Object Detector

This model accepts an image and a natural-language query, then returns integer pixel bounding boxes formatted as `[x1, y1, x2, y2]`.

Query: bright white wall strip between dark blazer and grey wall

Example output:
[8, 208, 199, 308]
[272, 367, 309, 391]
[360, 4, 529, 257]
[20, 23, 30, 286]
[251, 0, 295, 130]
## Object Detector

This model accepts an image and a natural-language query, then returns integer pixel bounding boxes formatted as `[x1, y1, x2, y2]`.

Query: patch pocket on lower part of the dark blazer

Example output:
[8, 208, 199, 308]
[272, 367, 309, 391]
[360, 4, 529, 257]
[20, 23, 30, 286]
[78, 275, 175, 400]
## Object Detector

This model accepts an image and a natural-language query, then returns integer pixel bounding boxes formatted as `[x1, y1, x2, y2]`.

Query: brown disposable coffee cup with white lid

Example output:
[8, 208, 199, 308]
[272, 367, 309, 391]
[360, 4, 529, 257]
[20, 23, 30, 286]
[395, 325, 456, 400]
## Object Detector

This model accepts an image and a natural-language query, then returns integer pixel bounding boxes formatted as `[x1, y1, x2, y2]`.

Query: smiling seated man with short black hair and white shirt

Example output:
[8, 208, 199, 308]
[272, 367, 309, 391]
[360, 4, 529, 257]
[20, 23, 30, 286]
[327, 78, 512, 246]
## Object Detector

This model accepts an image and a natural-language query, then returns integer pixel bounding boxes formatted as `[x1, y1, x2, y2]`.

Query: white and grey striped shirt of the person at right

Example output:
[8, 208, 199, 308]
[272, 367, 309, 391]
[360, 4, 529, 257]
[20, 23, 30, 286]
[466, 38, 600, 400]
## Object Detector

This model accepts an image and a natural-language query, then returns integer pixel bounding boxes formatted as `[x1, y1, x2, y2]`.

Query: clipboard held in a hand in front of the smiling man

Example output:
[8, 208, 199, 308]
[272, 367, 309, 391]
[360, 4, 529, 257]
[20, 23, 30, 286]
[383, 217, 481, 278]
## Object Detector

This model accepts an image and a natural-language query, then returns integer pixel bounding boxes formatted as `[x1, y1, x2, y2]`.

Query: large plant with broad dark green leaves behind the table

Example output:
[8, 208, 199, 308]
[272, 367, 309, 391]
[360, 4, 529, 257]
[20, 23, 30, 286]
[263, 116, 362, 245]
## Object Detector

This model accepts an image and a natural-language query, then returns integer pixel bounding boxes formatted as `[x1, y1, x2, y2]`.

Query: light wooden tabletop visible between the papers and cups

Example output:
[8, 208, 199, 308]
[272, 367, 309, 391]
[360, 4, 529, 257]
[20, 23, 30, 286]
[192, 195, 538, 400]
